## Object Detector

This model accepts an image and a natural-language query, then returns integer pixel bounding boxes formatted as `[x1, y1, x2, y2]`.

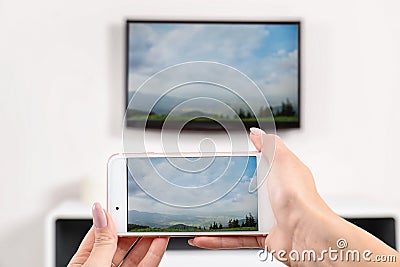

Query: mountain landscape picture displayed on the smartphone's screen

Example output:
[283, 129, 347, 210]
[127, 156, 258, 232]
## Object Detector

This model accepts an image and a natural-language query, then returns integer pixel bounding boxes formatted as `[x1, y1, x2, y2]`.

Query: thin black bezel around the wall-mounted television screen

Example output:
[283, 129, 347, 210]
[124, 19, 302, 130]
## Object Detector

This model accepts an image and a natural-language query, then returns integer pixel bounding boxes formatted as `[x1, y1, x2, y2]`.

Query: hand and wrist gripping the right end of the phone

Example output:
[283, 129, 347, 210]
[189, 128, 400, 267]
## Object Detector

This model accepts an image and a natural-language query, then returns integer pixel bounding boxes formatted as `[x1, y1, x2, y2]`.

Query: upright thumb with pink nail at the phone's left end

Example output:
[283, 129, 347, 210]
[85, 203, 118, 267]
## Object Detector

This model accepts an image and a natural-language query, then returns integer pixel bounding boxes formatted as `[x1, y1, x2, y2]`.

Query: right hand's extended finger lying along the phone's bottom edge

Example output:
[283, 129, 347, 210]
[189, 236, 265, 249]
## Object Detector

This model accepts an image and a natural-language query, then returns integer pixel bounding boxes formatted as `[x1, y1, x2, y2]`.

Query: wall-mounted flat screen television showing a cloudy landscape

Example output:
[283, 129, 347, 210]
[125, 20, 301, 130]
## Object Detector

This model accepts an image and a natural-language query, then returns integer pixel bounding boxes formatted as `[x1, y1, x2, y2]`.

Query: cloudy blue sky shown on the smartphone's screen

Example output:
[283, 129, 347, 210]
[128, 156, 257, 216]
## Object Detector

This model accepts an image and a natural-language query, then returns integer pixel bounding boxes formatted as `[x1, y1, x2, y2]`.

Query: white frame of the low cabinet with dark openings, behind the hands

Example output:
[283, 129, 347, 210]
[45, 201, 400, 267]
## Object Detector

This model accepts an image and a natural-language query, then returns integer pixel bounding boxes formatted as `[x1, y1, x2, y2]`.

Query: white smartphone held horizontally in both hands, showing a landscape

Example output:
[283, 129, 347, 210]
[107, 152, 275, 236]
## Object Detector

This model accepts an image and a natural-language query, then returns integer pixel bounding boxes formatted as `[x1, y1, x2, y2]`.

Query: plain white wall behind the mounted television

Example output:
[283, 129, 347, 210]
[0, 0, 400, 266]
